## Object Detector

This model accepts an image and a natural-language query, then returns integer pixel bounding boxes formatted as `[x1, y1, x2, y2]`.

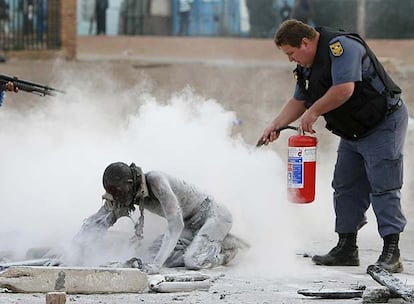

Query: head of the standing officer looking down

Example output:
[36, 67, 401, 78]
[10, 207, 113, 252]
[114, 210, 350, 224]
[274, 19, 319, 67]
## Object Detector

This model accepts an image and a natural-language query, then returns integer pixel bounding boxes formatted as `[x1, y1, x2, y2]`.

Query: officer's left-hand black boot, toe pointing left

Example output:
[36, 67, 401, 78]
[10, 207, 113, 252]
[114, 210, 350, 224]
[312, 233, 359, 266]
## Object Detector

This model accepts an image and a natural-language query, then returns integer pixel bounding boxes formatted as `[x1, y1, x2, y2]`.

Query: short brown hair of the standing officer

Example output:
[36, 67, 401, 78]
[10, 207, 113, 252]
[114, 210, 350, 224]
[274, 19, 316, 48]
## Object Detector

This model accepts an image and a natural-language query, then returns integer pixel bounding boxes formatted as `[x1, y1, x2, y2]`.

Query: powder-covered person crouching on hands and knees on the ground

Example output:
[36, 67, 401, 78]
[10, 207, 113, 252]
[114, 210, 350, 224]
[75, 162, 247, 273]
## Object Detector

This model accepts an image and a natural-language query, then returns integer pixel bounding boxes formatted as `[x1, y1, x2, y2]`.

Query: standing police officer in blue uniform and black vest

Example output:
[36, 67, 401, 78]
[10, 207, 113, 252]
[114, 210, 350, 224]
[259, 19, 408, 272]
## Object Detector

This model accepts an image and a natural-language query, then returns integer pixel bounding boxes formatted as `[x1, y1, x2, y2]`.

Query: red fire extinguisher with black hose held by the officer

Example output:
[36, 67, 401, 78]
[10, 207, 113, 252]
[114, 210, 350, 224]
[257, 126, 317, 204]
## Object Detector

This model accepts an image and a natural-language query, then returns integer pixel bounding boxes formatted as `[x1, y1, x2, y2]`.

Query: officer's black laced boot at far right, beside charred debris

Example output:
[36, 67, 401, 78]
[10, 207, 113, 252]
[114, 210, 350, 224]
[375, 234, 403, 272]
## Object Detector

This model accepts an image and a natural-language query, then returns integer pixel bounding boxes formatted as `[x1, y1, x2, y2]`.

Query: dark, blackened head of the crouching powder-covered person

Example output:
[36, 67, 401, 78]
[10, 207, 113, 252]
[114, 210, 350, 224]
[102, 162, 142, 206]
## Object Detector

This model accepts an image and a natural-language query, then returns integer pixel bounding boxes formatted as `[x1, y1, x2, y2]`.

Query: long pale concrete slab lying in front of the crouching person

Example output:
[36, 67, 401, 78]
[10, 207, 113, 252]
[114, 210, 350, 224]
[0, 267, 148, 294]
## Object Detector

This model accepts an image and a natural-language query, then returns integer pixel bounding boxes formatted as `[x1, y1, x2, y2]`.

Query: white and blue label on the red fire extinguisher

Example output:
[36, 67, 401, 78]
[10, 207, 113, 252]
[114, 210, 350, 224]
[287, 147, 316, 188]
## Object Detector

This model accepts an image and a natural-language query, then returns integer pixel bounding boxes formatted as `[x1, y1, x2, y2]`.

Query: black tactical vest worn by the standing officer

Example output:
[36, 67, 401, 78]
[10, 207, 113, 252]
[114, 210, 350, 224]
[295, 27, 401, 140]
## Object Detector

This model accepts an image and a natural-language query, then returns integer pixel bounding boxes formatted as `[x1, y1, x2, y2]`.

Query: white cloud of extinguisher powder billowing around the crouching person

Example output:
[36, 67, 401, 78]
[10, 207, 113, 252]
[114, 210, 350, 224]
[0, 63, 350, 276]
